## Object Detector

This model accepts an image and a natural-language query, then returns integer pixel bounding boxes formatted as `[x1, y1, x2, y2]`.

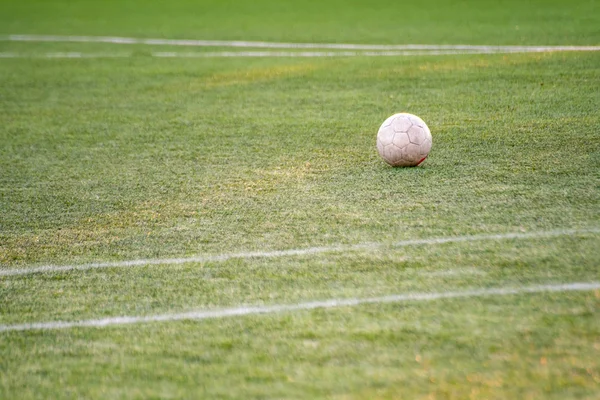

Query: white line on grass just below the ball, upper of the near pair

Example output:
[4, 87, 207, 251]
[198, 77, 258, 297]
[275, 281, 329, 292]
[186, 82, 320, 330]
[0, 228, 600, 277]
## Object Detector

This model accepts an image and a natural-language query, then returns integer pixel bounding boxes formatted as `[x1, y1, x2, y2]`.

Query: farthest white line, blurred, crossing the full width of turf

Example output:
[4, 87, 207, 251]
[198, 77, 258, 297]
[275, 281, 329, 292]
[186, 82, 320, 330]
[0, 35, 600, 52]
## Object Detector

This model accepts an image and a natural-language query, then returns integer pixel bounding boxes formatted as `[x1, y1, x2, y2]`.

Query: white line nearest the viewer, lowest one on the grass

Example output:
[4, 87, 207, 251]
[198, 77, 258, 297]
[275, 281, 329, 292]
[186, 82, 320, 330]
[0, 282, 600, 332]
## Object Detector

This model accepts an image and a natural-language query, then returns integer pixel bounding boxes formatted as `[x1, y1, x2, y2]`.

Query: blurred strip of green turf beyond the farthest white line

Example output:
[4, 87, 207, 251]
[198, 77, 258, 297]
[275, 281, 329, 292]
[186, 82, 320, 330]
[0, 0, 600, 44]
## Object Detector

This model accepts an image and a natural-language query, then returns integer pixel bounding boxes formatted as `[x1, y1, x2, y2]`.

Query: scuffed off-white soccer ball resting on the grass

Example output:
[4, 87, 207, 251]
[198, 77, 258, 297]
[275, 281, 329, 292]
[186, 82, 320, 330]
[377, 113, 431, 167]
